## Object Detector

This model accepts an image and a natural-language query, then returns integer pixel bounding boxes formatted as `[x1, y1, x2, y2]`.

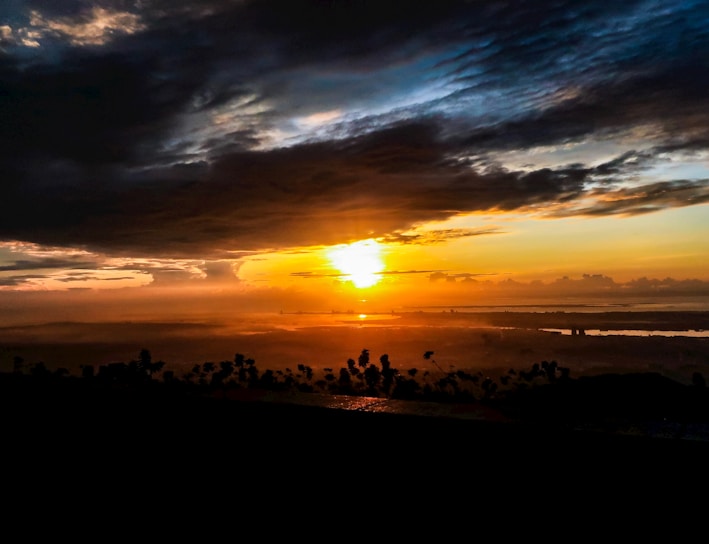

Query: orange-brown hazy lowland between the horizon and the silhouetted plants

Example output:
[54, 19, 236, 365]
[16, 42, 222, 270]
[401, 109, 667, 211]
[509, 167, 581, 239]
[0, 308, 709, 383]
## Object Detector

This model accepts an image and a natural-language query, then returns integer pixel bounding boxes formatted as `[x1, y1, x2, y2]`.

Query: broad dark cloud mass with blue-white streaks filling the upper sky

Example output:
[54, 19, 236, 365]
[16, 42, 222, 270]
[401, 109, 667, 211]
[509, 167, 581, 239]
[0, 0, 709, 258]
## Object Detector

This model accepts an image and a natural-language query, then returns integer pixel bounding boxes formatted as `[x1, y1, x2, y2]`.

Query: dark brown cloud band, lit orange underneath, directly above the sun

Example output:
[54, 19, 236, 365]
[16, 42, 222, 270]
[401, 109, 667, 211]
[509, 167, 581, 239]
[0, 124, 588, 256]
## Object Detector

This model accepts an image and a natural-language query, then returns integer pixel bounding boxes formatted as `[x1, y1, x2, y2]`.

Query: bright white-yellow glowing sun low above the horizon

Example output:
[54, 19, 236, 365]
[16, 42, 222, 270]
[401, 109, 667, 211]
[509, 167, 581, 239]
[327, 240, 384, 289]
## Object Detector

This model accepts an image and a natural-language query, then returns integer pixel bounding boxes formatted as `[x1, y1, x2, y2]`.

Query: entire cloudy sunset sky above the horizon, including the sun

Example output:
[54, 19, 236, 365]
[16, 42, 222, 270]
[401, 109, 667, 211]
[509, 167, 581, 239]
[0, 0, 709, 322]
